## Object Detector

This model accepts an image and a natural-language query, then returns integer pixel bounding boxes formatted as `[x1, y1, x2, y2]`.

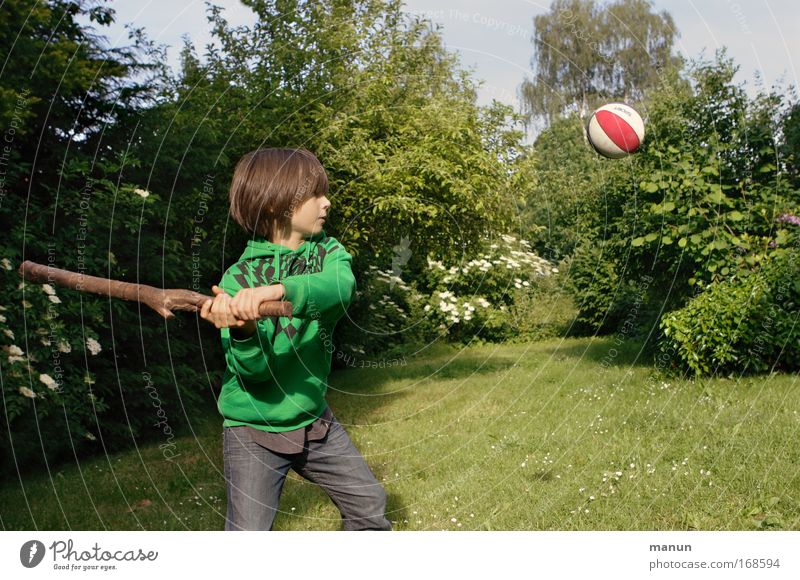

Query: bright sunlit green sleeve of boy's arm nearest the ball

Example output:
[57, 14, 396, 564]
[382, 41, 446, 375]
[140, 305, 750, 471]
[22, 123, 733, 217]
[281, 240, 356, 324]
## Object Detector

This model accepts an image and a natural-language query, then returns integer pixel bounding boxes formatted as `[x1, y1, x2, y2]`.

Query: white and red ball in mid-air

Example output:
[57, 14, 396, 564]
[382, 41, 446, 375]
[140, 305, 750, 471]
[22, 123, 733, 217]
[586, 103, 644, 159]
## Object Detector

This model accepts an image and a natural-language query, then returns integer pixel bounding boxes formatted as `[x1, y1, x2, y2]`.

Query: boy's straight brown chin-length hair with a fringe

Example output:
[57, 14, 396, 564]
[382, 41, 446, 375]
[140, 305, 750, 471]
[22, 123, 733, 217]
[229, 148, 328, 240]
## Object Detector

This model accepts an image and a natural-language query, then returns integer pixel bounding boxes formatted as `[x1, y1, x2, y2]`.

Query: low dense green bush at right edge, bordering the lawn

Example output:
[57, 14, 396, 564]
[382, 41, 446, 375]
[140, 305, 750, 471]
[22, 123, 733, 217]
[661, 241, 800, 374]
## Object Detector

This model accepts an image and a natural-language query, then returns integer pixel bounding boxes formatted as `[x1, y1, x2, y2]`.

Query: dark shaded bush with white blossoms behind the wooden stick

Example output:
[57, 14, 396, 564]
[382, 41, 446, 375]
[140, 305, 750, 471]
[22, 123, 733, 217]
[0, 172, 206, 471]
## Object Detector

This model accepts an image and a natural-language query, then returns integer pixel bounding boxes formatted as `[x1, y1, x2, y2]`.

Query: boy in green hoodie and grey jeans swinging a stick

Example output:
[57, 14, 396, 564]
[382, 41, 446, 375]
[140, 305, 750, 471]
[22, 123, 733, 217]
[200, 149, 391, 530]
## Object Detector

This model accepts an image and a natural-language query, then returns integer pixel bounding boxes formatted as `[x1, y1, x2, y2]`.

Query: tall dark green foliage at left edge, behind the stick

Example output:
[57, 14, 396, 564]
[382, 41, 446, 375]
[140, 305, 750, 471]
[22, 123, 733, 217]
[0, 1, 200, 474]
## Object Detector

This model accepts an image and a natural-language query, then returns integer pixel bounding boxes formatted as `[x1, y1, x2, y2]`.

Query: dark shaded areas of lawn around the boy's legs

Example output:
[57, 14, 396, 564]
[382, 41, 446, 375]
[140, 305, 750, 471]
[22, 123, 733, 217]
[0, 344, 532, 530]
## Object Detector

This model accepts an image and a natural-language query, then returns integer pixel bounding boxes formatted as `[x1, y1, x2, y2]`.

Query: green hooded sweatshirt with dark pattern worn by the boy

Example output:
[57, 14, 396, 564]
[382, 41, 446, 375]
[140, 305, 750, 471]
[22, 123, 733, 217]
[217, 230, 356, 432]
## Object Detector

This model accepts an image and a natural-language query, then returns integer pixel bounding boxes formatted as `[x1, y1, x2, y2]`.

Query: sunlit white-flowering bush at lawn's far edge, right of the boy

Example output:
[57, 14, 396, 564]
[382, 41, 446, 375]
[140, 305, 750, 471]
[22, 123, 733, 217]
[337, 235, 574, 363]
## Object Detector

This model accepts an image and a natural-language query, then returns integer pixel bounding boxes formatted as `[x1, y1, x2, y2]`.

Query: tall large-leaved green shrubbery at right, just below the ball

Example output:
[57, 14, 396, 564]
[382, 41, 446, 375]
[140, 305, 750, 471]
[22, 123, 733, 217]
[571, 55, 800, 338]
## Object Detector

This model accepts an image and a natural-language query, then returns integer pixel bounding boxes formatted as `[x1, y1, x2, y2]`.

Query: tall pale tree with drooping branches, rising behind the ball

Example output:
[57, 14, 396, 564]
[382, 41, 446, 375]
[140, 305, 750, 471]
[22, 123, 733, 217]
[520, 0, 679, 124]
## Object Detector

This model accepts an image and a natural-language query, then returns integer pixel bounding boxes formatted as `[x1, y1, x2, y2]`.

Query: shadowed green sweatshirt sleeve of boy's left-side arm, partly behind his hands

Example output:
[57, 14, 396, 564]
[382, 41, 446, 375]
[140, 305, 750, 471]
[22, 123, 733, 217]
[220, 274, 274, 384]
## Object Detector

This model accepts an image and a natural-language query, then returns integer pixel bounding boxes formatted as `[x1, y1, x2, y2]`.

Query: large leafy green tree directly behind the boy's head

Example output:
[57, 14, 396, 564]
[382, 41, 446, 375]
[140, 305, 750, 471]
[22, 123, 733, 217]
[130, 0, 521, 274]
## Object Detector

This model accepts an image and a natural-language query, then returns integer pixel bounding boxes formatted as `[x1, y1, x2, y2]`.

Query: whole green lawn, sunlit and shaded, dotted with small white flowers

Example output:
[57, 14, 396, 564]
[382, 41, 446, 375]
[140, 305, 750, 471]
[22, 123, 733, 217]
[0, 338, 800, 530]
